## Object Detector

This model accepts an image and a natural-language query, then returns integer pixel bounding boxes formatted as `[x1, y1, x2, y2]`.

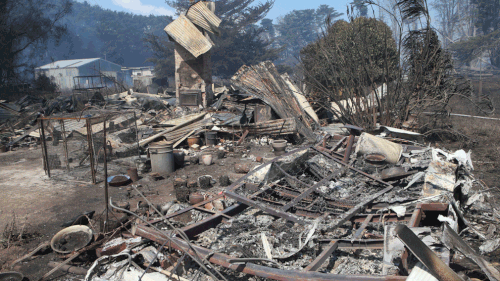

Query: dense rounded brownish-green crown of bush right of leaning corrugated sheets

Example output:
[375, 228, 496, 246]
[301, 17, 398, 91]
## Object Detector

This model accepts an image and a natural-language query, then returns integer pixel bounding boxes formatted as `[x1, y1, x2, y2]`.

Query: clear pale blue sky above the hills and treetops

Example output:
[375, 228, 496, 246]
[78, 0, 352, 19]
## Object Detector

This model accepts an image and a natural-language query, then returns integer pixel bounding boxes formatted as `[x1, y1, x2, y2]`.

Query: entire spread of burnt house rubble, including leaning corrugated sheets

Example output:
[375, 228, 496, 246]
[2, 60, 500, 281]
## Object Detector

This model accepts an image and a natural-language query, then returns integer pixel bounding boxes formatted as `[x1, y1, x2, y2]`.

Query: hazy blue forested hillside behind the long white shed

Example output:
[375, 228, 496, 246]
[37, 2, 172, 66]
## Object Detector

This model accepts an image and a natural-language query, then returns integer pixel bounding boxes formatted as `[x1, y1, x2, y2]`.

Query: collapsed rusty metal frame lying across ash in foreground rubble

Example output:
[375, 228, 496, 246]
[135, 146, 448, 281]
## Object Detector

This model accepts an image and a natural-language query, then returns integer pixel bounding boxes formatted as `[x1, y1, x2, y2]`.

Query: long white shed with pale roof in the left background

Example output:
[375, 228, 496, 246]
[35, 58, 126, 91]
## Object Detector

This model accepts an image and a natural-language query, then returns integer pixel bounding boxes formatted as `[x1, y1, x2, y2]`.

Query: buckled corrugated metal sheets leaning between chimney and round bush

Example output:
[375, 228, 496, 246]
[231, 61, 316, 140]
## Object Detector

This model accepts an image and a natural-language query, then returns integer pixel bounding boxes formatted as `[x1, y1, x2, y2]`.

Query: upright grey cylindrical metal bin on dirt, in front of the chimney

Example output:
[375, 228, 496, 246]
[149, 143, 175, 175]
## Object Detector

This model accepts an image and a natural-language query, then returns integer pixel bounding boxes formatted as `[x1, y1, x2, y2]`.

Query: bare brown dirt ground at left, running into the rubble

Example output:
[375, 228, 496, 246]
[0, 140, 272, 280]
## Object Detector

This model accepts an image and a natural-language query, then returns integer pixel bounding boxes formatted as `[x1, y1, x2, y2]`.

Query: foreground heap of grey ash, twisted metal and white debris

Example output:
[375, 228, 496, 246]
[4, 112, 500, 280]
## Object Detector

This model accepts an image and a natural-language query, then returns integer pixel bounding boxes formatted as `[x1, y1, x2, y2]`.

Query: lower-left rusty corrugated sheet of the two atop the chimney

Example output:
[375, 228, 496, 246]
[165, 15, 212, 57]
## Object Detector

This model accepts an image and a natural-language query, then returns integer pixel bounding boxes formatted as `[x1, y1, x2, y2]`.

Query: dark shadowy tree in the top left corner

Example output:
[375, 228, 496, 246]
[0, 0, 72, 89]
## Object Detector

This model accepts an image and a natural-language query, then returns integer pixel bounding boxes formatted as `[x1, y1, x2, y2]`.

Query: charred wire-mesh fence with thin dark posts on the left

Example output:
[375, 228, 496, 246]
[38, 111, 140, 184]
